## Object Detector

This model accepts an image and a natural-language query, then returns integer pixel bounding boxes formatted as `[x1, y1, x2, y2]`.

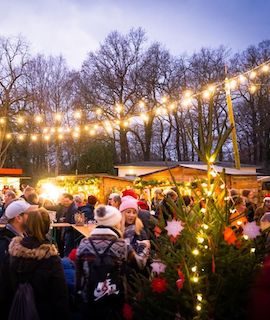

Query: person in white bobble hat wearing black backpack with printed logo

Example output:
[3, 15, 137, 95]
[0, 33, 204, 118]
[76, 205, 128, 320]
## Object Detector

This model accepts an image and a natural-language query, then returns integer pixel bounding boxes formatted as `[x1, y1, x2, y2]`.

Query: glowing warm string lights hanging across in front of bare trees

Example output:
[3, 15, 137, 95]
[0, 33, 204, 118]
[0, 60, 270, 142]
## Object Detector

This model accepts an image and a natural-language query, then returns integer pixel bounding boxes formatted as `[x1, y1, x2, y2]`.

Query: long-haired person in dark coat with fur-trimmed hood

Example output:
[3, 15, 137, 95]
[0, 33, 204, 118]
[9, 208, 70, 320]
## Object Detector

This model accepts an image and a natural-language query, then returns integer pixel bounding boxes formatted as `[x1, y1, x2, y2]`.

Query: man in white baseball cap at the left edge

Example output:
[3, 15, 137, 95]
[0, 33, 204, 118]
[0, 199, 37, 319]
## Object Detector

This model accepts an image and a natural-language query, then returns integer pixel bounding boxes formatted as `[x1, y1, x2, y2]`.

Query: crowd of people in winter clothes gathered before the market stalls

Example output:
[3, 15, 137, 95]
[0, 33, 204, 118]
[0, 186, 270, 320]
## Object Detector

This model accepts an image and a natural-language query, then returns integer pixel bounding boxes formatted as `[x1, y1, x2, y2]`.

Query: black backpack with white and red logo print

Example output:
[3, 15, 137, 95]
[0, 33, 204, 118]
[87, 238, 124, 303]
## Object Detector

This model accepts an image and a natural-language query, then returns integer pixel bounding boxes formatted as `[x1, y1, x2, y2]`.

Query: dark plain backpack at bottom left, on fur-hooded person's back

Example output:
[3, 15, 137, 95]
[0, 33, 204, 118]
[8, 282, 39, 320]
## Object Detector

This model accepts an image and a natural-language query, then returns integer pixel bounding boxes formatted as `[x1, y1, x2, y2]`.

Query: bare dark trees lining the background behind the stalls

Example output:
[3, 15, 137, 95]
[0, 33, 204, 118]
[0, 29, 270, 180]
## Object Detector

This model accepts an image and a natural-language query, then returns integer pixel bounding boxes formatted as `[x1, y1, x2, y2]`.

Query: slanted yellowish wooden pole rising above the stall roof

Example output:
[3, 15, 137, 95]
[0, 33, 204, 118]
[225, 78, 240, 169]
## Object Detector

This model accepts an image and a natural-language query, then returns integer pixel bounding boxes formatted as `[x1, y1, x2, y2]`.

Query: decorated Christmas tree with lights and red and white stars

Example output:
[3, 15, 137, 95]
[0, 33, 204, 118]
[130, 97, 263, 320]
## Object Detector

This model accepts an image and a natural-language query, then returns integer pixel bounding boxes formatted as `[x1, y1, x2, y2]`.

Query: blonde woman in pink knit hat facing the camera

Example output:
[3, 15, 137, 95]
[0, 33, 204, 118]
[119, 197, 150, 270]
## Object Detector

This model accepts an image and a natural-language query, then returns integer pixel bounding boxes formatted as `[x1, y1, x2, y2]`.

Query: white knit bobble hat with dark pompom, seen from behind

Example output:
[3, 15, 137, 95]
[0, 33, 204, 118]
[95, 205, 122, 227]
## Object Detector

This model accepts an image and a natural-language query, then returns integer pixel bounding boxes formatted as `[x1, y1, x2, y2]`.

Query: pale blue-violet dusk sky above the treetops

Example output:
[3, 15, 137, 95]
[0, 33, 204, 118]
[0, 0, 270, 68]
